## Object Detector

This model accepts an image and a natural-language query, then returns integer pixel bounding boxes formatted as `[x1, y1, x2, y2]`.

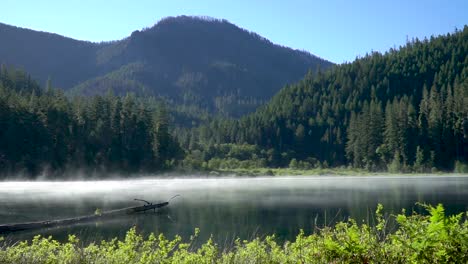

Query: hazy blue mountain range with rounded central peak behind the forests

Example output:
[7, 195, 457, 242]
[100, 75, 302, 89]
[0, 16, 332, 115]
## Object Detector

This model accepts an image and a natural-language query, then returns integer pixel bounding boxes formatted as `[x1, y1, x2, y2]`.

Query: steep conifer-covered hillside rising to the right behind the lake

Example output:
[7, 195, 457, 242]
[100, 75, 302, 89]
[188, 26, 468, 171]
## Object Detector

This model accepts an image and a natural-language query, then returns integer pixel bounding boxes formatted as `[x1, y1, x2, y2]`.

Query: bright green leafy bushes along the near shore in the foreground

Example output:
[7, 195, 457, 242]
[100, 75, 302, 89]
[0, 205, 468, 264]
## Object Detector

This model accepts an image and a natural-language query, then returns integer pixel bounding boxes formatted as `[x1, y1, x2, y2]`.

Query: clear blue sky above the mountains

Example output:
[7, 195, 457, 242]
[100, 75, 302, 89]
[0, 0, 468, 63]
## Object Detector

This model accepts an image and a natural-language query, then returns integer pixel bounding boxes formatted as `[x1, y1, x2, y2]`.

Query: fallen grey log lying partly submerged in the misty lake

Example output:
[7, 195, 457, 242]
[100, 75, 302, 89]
[0, 195, 179, 234]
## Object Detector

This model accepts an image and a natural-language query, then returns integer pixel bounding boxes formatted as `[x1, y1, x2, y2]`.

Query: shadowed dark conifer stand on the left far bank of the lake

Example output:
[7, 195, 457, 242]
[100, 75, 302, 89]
[0, 66, 183, 175]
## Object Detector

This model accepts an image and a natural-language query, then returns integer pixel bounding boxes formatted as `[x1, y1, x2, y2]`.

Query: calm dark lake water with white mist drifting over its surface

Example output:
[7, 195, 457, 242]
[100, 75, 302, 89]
[0, 175, 468, 245]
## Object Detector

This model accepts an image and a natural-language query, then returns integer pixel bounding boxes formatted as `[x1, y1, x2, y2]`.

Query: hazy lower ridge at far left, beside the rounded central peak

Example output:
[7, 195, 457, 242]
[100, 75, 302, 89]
[0, 20, 101, 89]
